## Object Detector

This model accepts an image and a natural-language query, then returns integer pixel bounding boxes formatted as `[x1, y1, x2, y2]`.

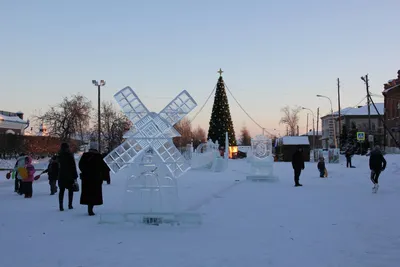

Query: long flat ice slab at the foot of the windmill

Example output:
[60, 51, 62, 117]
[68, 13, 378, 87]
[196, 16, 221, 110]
[99, 212, 202, 226]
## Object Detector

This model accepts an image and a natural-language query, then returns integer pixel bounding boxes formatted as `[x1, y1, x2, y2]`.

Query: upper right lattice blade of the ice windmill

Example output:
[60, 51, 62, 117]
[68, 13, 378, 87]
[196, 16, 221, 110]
[159, 90, 197, 126]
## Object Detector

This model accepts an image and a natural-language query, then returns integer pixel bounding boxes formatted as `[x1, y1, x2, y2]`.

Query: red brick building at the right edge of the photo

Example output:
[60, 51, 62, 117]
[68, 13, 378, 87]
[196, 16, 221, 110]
[382, 70, 400, 147]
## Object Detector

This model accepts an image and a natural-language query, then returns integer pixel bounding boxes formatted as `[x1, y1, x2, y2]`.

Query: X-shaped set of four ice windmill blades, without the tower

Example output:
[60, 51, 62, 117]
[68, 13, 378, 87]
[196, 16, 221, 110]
[104, 86, 197, 178]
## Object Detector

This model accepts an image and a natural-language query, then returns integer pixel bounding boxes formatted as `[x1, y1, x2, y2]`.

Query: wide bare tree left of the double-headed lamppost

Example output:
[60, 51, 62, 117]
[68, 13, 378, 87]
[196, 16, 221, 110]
[36, 94, 92, 141]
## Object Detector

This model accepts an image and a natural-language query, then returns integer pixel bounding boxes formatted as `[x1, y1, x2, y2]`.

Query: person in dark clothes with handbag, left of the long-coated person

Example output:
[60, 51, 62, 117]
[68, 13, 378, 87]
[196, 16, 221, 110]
[57, 143, 78, 211]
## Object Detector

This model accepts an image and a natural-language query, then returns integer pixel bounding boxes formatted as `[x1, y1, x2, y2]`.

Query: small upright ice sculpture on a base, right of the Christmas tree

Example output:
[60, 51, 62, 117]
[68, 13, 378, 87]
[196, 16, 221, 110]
[247, 135, 276, 180]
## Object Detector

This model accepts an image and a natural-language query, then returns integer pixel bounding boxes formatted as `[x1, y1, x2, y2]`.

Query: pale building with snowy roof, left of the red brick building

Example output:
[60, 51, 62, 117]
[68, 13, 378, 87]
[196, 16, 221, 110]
[321, 103, 384, 149]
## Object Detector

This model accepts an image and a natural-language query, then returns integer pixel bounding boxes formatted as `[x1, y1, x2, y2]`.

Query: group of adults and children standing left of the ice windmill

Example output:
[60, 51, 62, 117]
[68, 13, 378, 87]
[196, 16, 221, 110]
[14, 142, 111, 216]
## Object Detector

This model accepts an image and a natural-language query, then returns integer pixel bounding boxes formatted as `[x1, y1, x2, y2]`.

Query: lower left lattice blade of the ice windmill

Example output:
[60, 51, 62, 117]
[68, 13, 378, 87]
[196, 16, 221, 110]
[104, 138, 149, 174]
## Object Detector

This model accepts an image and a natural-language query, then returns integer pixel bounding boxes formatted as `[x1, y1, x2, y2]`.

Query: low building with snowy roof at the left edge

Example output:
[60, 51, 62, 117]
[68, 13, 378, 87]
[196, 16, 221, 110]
[0, 110, 29, 135]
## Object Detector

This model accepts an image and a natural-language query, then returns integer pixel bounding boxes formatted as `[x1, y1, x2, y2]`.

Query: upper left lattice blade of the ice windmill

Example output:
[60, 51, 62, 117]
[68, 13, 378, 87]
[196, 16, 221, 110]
[114, 86, 150, 125]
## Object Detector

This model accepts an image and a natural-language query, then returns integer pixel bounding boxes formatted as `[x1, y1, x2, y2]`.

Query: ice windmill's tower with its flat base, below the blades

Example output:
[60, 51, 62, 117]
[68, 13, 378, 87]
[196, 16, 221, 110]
[100, 149, 201, 225]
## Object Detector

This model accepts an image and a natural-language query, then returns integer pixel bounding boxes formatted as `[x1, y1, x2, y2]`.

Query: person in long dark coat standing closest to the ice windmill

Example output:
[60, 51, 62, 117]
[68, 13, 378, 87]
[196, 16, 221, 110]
[79, 142, 107, 216]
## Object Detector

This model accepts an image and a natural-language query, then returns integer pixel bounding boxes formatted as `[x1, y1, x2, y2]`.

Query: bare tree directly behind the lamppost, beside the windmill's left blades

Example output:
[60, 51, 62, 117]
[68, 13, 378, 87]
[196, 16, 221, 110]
[91, 102, 131, 150]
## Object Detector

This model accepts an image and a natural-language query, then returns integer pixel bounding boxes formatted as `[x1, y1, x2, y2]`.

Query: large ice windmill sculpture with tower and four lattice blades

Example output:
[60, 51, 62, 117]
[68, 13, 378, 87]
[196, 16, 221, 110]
[100, 87, 197, 224]
